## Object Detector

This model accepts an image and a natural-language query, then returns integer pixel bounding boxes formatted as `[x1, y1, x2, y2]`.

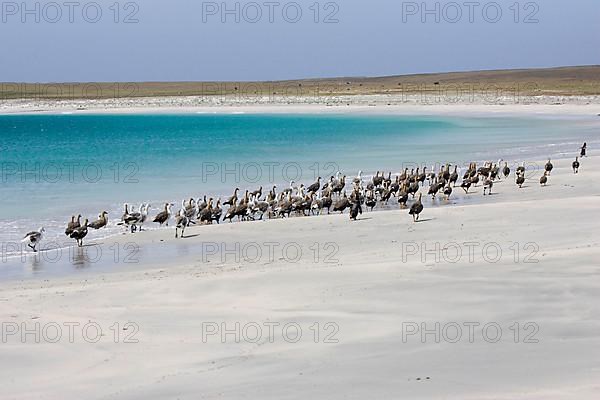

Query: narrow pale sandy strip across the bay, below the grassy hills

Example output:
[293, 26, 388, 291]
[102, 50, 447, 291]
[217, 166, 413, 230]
[0, 95, 600, 117]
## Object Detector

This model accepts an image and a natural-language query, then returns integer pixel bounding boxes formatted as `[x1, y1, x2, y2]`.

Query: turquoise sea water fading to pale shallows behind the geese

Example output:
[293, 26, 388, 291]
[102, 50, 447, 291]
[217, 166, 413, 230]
[0, 114, 598, 255]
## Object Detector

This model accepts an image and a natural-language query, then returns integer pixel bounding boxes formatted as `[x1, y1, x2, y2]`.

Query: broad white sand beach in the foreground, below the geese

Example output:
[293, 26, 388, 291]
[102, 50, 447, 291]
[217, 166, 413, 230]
[0, 151, 600, 400]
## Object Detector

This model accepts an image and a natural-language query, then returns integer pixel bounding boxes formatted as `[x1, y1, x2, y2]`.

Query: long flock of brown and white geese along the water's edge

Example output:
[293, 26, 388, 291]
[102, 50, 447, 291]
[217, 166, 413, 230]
[23, 152, 586, 252]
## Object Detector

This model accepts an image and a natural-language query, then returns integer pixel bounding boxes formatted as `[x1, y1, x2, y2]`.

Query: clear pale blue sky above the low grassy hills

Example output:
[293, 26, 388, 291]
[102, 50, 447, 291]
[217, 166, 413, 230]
[0, 0, 600, 82]
